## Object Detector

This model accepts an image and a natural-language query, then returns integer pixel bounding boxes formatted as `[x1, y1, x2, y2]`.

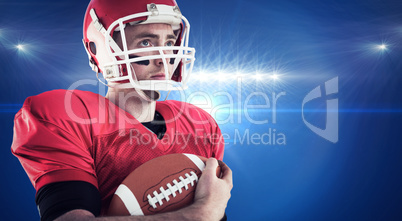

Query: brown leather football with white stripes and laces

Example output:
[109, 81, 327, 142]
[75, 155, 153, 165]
[107, 153, 220, 216]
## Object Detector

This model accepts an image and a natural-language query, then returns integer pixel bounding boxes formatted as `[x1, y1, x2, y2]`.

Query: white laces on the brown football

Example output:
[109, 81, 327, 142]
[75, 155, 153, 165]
[147, 171, 198, 209]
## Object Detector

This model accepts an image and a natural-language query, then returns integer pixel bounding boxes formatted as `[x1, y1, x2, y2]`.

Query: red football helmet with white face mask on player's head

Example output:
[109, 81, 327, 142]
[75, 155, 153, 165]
[83, 0, 195, 90]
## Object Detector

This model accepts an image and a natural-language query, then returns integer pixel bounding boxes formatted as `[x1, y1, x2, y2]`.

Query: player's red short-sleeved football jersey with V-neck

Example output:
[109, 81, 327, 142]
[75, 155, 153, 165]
[11, 90, 224, 214]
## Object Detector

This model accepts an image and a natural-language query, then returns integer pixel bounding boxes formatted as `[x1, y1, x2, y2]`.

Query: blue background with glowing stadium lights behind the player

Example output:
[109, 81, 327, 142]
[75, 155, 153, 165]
[0, 0, 402, 220]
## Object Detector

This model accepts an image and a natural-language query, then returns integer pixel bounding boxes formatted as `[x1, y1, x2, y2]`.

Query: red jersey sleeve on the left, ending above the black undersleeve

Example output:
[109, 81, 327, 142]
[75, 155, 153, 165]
[11, 91, 98, 191]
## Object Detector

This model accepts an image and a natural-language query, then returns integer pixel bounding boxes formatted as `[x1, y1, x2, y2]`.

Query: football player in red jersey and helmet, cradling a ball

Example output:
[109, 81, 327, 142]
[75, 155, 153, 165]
[12, 0, 232, 220]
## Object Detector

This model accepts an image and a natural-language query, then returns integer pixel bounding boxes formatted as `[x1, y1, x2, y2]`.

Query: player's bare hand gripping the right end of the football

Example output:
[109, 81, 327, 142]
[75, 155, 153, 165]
[194, 158, 233, 220]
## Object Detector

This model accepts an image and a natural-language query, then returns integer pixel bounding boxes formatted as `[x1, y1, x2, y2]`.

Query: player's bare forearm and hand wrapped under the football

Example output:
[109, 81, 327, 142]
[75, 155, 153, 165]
[56, 158, 233, 221]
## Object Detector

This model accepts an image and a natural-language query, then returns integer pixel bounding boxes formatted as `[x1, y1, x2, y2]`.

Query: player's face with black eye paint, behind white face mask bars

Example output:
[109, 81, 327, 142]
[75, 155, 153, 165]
[119, 24, 177, 81]
